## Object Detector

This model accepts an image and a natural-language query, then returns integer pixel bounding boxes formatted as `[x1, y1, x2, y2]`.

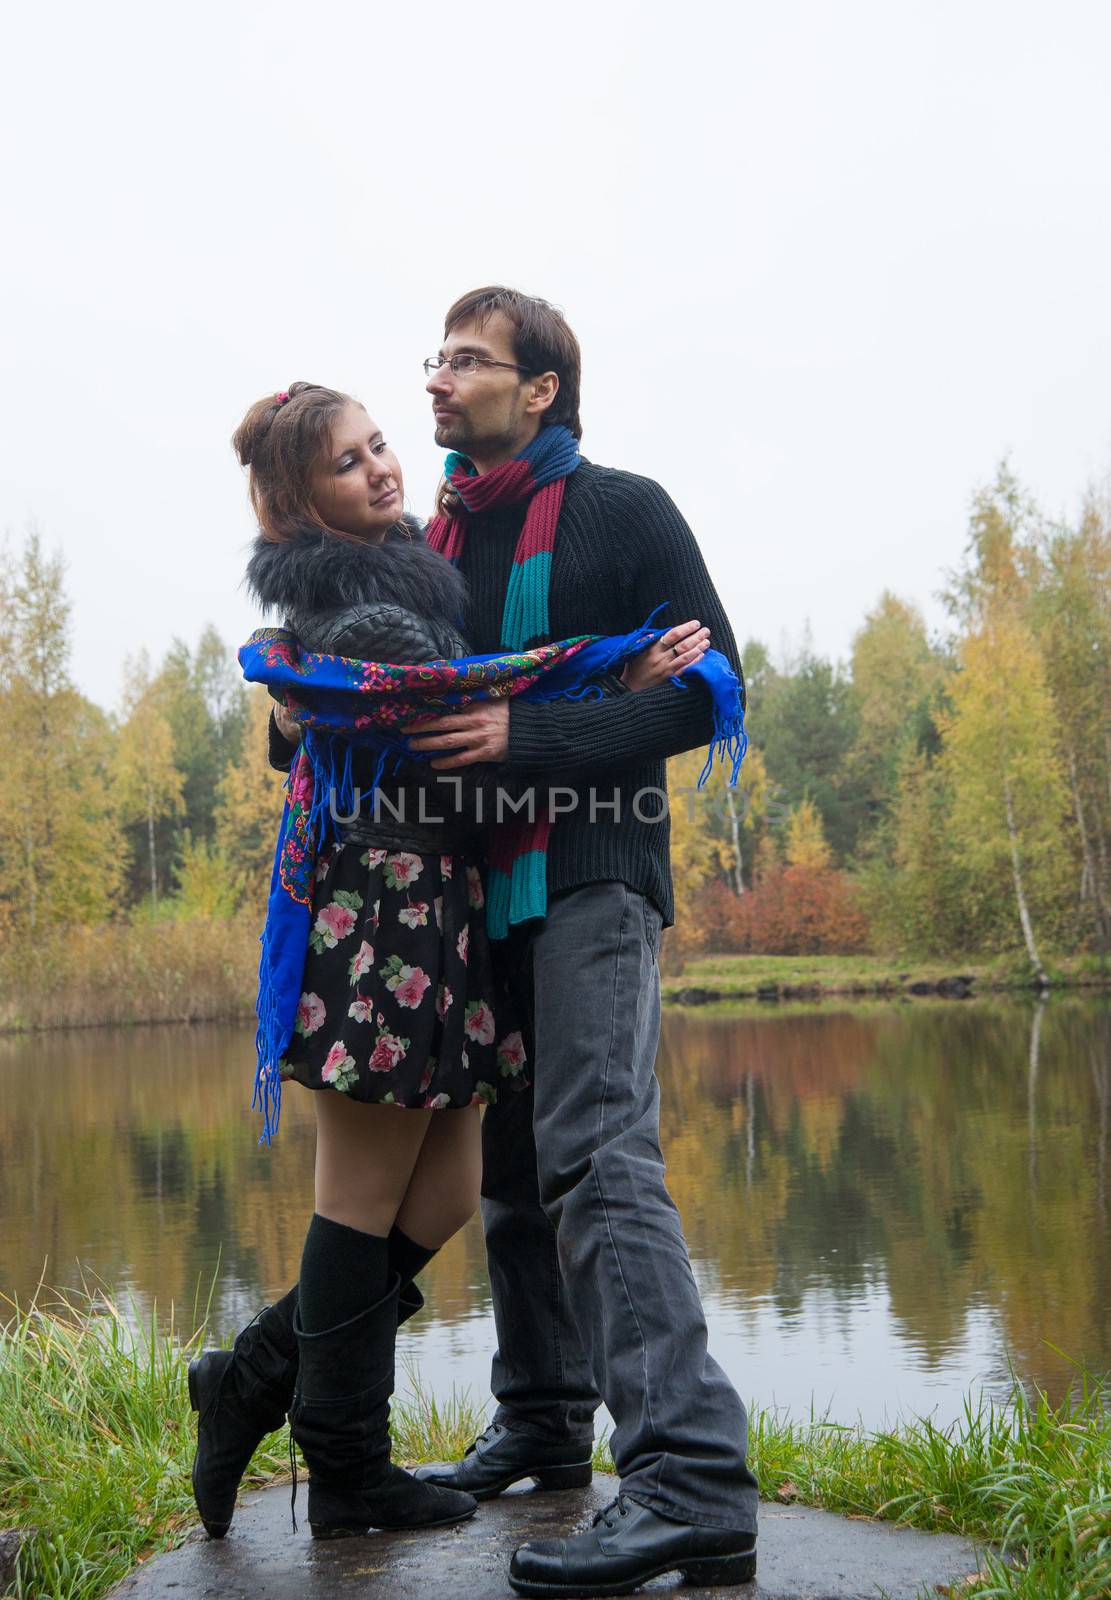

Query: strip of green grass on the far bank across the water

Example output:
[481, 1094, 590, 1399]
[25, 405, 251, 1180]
[663, 954, 1111, 1000]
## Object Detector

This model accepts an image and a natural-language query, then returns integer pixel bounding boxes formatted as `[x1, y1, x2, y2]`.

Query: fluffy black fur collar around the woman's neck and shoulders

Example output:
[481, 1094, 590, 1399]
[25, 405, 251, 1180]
[245, 515, 464, 626]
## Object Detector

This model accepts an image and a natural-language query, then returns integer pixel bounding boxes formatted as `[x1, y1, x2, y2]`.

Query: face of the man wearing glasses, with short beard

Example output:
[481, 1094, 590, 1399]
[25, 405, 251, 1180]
[424, 312, 539, 459]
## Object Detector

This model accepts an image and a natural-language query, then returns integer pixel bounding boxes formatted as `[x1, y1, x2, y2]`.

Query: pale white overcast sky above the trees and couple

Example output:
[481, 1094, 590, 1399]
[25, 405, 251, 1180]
[0, 0, 1111, 706]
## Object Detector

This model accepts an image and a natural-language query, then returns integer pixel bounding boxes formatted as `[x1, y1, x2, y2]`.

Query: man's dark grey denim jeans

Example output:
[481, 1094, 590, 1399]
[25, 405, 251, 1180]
[482, 883, 757, 1531]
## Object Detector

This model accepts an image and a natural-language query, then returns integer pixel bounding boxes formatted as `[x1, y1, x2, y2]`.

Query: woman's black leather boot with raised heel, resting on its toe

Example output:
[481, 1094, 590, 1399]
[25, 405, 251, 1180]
[189, 1285, 298, 1539]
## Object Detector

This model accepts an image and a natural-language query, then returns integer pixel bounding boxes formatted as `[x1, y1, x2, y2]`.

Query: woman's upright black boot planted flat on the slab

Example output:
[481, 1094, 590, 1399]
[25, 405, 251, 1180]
[290, 1280, 477, 1539]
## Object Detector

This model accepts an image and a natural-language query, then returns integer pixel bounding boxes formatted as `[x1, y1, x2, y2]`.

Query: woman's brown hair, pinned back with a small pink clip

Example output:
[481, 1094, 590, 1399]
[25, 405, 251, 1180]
[232, 382, 359, 544]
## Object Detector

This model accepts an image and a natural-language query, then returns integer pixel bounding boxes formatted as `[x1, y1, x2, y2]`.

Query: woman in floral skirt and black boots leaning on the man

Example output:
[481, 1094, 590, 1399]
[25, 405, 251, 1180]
[189, 384, 706, 1538]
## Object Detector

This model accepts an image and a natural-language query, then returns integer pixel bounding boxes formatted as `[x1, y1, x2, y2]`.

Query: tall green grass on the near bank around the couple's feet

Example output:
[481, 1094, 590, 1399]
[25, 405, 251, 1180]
[0, 1302, 1111, 1600]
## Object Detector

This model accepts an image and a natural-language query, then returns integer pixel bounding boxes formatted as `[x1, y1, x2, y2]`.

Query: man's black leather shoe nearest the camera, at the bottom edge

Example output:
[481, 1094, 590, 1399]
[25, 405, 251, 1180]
[509, 1494, 756, 1595]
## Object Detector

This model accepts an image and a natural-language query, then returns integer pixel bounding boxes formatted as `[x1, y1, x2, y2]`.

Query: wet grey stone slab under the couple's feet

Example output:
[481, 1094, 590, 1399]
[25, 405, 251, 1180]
[112, 1474, 980, 1600]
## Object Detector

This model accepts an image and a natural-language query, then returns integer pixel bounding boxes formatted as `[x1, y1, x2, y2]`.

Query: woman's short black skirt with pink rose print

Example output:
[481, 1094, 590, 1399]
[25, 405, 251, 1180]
[282, 842, 528, 1110]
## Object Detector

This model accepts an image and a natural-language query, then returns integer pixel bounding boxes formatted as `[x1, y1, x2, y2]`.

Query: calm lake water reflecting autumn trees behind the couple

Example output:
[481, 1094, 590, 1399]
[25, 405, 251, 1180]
[0, 998, 1111, 1426]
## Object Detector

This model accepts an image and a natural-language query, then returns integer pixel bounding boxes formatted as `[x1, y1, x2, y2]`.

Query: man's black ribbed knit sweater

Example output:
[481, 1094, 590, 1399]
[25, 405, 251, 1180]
[461, 461, 740, 925]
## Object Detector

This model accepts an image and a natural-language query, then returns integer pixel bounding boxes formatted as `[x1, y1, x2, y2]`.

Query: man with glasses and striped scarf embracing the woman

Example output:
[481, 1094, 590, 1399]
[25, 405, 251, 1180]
[415, 288, 757, 1595]
